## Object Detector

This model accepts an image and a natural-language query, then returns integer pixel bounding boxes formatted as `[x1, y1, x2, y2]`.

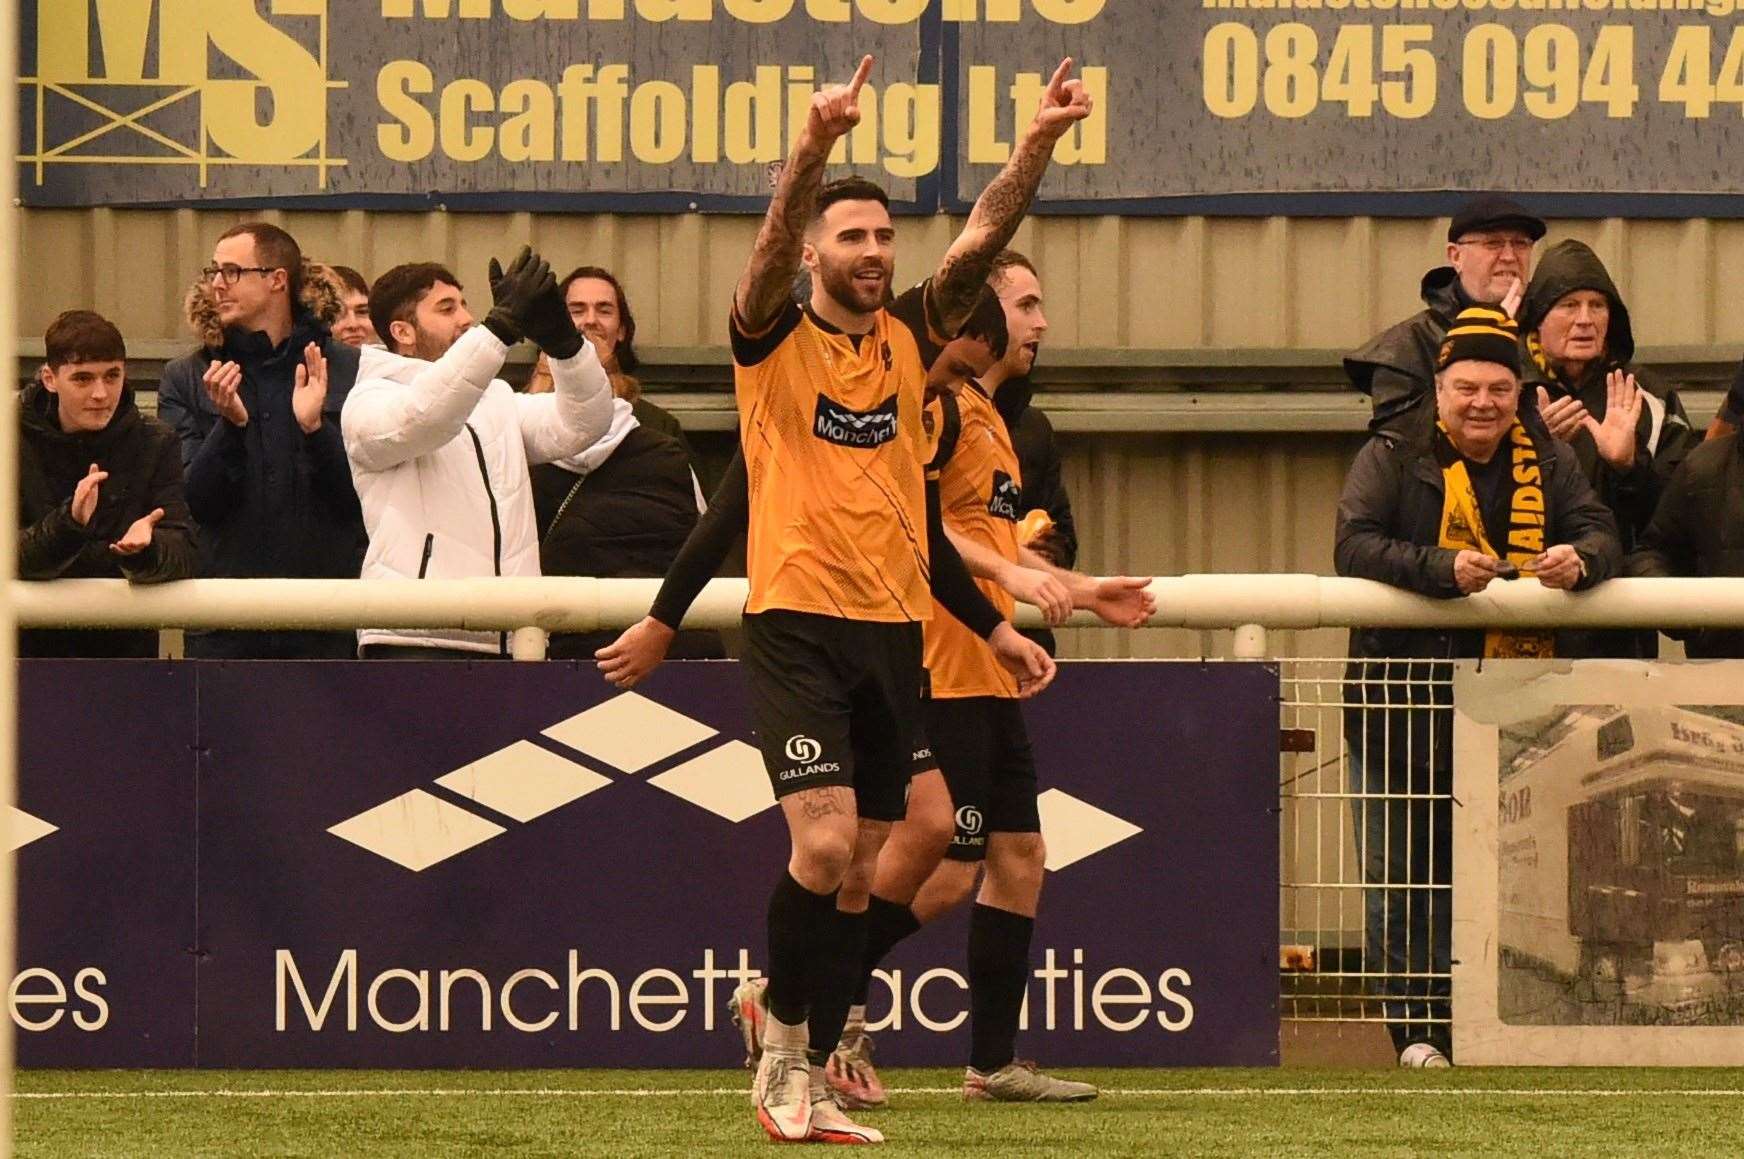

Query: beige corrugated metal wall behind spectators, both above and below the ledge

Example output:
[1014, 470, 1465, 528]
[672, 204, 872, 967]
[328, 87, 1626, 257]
[21, 209, 1744, 655]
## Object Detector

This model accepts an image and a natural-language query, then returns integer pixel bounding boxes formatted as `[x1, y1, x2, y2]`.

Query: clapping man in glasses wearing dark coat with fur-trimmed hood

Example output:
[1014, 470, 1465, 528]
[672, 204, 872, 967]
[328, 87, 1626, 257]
[157, 221, 363, 659]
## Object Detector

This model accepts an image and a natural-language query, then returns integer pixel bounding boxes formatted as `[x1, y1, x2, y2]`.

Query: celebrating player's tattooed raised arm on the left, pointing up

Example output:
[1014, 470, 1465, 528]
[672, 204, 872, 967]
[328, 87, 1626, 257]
[732, 56, 872, 335]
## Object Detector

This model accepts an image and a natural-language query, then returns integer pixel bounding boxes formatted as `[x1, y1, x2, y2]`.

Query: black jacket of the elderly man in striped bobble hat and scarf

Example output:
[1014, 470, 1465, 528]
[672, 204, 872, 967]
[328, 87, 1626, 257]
[1332, 417, 1622, 680]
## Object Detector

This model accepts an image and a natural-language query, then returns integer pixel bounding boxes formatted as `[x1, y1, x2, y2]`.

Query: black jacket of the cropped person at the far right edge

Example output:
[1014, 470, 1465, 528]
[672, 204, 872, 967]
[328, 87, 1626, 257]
[1624, 434, 1744, 661]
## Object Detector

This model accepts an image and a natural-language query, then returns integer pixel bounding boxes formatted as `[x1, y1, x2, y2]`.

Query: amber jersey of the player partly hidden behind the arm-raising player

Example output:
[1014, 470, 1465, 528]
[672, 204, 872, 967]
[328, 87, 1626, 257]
[926, 382, 1024, 699]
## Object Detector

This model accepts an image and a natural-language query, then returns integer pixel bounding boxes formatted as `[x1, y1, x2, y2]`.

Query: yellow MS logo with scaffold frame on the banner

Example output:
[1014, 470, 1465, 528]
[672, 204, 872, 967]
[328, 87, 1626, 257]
[19, 0, 345, 188]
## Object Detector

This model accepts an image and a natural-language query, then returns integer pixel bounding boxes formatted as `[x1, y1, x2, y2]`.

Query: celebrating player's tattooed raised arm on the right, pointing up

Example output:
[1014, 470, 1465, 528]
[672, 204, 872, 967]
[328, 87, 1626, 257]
[933, 58, 1090, 338]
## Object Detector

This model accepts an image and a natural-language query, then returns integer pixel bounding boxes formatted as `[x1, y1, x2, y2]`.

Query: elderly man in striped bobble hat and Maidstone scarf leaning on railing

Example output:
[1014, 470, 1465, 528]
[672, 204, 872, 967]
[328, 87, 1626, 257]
[1334, 307, 1622, 1067]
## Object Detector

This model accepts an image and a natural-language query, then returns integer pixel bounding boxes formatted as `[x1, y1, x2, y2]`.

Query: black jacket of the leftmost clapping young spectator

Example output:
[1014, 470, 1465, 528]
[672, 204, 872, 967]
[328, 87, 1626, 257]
[17, 383, 194, 657]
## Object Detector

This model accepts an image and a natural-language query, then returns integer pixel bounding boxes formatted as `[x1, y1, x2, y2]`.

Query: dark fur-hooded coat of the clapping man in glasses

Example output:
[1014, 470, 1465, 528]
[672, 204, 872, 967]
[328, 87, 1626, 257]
[157, 312, 364, 579]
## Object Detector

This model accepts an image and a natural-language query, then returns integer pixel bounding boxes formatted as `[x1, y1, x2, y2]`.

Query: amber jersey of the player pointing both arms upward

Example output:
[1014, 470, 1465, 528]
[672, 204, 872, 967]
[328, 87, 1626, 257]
[732, 284, 933, 622]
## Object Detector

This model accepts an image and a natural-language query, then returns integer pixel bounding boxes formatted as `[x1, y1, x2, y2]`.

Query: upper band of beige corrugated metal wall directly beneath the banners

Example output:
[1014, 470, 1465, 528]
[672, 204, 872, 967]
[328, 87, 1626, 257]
[30, 209, 1744, 349]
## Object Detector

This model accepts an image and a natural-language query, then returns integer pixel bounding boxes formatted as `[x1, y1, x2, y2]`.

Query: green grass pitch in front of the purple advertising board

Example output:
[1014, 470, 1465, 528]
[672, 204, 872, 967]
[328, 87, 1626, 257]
[14, 1068, 1744, 1159]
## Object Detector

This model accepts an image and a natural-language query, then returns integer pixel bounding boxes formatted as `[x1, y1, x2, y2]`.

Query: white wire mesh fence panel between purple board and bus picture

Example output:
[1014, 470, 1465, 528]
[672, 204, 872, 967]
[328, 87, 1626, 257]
[1278, 659, 1453, 1039]
